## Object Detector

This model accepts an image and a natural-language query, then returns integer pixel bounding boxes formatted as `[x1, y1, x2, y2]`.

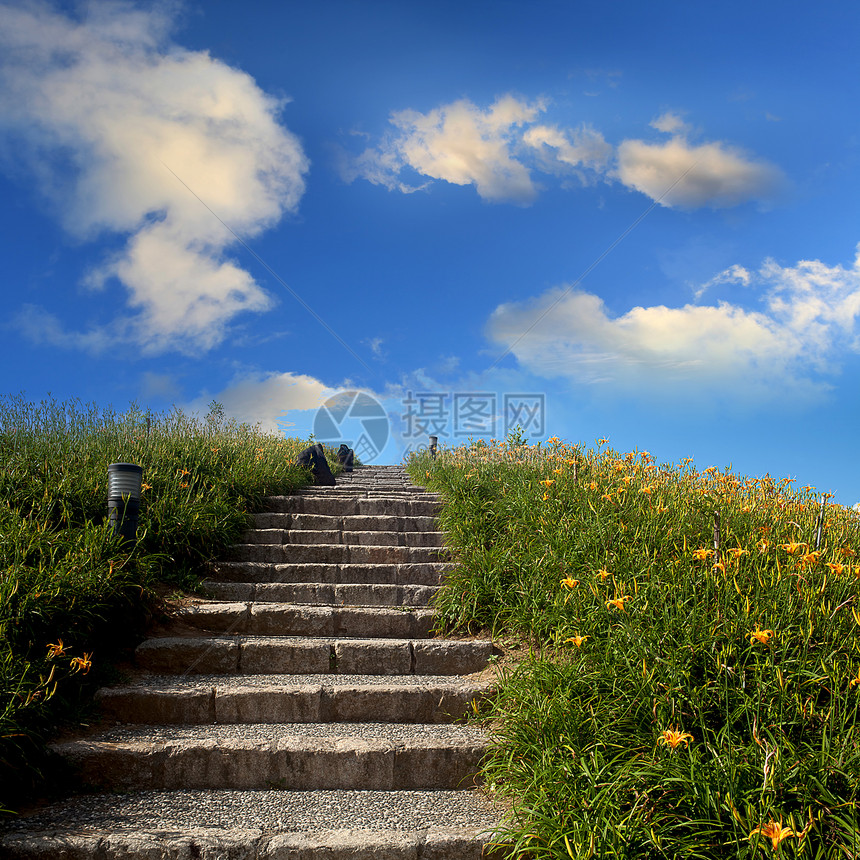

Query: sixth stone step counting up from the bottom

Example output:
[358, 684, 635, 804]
[203, 580, 439, 606]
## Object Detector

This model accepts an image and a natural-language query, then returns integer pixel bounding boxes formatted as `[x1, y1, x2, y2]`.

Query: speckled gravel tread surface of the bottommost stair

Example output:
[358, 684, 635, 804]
[0, 790, 500, 832]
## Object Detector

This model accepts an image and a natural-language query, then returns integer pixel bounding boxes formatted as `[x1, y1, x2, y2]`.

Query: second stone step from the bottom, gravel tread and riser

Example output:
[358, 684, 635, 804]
[51, 723, 487, 791]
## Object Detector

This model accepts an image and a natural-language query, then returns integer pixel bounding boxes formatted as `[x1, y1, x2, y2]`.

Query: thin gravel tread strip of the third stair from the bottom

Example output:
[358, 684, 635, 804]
[115, 675, 488, 690]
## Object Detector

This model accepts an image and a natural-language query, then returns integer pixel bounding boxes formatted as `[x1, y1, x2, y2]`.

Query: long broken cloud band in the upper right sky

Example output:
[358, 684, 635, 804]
[338, 94, 783, 208]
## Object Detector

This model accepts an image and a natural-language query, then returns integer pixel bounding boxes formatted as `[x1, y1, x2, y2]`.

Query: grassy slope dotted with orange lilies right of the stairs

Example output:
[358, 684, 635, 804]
[408, 440, 860, 858]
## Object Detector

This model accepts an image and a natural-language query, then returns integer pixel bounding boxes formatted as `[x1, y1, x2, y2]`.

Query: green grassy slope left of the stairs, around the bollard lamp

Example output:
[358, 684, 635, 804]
[0, 397, 338, 810]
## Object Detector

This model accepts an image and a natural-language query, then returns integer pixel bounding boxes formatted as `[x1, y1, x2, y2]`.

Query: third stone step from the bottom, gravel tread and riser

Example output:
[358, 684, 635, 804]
[96, 675, 492, 725]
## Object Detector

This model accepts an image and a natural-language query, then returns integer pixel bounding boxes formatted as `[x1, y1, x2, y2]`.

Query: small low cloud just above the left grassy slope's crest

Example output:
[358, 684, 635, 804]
[185, 373, 338, 435]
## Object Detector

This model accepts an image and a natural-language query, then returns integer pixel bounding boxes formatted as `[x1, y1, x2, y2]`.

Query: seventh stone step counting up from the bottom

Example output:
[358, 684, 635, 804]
[210, 561, 455, 585]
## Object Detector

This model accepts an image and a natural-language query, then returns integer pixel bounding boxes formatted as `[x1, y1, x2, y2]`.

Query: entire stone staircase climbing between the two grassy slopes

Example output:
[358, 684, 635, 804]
[0, 466, 499, 860]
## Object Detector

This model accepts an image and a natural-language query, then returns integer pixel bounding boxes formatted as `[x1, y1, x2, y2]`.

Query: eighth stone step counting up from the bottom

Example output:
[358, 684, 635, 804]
[227, 543, 450, 564]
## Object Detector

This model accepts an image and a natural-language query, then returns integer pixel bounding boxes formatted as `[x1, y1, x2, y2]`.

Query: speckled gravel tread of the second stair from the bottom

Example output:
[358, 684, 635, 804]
[66, 723, 486, 745]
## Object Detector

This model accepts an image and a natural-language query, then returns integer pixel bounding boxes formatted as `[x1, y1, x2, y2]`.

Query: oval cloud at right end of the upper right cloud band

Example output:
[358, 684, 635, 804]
[616, 136, 782, 209]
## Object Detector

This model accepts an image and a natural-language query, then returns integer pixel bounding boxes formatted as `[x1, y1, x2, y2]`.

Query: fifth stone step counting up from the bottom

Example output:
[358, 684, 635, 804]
[173, 601, 435, 639]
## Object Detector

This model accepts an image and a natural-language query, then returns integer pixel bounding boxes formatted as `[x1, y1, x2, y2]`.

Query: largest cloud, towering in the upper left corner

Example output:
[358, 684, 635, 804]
[0, 2, 308, 352]
